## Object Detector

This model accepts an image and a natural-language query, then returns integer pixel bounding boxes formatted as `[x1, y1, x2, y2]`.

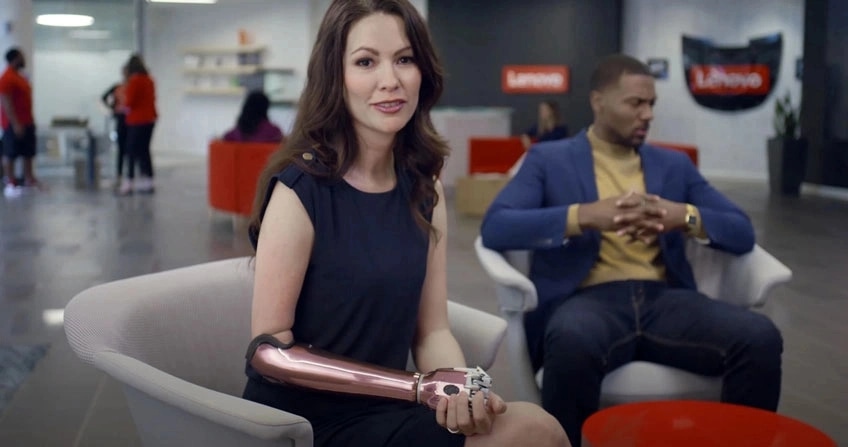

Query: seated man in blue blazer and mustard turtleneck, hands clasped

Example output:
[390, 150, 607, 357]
[482, 55, 783, 446]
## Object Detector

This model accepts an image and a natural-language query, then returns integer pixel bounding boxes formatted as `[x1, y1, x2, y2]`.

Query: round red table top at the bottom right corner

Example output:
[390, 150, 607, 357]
[583, 401, 836, 447]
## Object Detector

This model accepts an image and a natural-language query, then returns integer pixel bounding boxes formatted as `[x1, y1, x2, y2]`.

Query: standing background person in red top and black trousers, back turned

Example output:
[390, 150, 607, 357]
[118, 54, 157, 195]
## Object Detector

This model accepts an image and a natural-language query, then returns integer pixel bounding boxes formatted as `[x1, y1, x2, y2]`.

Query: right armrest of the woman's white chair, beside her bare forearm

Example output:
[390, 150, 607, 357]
[448, 301, 506, 369]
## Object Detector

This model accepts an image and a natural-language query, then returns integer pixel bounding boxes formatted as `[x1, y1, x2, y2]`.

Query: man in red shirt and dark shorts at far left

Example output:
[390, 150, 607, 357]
[0, 48, 39, 194]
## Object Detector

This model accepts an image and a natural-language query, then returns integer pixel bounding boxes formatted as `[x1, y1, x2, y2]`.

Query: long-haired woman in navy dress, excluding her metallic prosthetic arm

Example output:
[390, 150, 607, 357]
[244, 0, 569, 447]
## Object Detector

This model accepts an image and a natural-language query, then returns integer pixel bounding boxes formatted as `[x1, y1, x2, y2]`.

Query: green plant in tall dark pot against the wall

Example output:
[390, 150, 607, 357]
[768, 92, 807, 196]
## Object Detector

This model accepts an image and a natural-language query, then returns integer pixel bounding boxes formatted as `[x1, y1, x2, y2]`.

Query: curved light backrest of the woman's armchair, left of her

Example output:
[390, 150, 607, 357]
[65, 258, 253, 396]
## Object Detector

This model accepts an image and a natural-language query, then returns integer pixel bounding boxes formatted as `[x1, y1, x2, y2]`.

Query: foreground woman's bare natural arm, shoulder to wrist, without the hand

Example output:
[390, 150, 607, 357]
[412, 181, 466, 371]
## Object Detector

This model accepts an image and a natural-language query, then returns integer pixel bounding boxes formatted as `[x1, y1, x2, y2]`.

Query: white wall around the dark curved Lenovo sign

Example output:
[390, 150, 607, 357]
[622, 0, 804, 179]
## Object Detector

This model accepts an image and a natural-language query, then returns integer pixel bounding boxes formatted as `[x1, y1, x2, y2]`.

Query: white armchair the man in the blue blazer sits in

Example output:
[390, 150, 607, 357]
[474, 237, 792, 406]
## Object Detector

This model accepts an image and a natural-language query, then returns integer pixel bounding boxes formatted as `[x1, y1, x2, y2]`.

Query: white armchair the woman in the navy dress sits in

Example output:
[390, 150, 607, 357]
[65, 258, 506, 447]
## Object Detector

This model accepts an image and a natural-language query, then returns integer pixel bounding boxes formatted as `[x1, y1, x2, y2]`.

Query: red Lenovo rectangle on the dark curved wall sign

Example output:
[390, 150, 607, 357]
[689, 64, 771, 95]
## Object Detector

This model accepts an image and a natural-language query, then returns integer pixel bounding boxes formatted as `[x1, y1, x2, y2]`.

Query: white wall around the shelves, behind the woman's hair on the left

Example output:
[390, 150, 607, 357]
[145, 0, 427, 154]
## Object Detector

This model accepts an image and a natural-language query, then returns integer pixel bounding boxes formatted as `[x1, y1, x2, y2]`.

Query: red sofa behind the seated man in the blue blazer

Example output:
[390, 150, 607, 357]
[468, 137, 698, 175]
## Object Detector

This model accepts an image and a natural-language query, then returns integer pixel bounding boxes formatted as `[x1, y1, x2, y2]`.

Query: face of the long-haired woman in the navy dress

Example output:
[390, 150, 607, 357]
[344, 13, 421, 145]
